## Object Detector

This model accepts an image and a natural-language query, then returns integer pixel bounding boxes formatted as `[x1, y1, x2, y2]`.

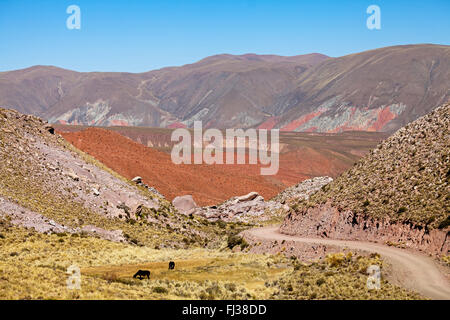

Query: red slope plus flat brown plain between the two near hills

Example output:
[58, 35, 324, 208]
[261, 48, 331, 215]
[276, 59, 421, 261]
[56, 126, 385, 205]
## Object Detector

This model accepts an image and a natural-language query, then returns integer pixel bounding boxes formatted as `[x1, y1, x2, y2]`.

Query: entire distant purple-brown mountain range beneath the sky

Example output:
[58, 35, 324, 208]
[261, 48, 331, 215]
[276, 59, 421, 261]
[0, 44, 450, 132]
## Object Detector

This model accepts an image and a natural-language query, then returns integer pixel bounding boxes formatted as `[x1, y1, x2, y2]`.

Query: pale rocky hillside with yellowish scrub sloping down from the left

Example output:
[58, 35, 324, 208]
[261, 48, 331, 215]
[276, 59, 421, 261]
[0, 109, 244, 247]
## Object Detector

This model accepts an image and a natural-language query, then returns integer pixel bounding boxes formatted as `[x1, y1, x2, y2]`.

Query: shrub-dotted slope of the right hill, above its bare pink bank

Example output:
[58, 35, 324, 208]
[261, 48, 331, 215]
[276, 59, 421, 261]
[291, 104, 450, 230]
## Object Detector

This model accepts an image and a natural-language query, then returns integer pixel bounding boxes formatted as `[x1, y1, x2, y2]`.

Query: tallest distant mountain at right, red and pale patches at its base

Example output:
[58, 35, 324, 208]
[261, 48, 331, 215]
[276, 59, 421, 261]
[271, 45, 450, 132]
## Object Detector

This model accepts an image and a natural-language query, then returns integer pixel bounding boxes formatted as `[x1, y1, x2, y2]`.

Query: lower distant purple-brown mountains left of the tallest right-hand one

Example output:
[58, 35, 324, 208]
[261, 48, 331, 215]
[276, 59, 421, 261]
[0, 54, 328, 127]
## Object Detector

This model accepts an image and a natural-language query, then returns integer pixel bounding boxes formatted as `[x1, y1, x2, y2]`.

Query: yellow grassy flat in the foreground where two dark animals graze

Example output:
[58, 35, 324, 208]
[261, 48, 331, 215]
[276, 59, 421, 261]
[0, 220, 421, 299]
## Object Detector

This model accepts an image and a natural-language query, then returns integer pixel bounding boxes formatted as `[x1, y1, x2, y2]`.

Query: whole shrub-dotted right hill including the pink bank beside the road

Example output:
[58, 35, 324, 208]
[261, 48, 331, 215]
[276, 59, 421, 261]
[281, 104, 450, 254]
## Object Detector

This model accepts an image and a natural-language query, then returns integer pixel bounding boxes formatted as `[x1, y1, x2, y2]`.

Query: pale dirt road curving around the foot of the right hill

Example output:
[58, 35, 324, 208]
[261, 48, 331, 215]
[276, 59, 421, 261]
[246, 226, 450, 300]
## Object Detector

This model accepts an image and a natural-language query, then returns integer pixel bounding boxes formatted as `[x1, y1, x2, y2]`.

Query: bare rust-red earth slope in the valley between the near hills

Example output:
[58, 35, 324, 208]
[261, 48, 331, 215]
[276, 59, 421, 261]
[57, 128, 384, 206]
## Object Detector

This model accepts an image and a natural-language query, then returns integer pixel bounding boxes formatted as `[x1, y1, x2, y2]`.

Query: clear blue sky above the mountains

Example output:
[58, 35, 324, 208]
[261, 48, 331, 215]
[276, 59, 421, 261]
[0, 0, 450, 72]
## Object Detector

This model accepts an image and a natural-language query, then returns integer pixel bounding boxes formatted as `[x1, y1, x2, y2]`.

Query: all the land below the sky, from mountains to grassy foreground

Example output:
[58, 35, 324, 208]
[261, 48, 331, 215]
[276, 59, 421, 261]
[0, 44, 450, 300]
